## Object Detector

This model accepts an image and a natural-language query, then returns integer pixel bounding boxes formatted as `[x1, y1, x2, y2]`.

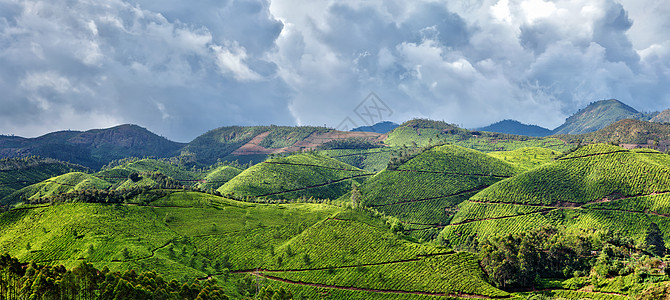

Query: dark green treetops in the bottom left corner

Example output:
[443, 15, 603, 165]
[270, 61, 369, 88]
[0, 254, 231, 300]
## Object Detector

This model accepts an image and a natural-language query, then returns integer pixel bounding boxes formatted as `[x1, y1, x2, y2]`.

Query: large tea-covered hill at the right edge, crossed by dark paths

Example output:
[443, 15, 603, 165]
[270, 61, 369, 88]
[441, 144, 670, 245]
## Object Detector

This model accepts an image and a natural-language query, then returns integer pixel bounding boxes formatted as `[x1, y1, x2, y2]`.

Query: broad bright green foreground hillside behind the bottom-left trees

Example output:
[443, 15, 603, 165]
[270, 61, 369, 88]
[0, 192, 510, 299]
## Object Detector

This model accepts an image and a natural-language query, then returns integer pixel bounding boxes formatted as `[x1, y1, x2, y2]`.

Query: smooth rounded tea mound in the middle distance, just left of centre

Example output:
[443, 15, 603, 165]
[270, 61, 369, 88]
[217, 153, 372, 199]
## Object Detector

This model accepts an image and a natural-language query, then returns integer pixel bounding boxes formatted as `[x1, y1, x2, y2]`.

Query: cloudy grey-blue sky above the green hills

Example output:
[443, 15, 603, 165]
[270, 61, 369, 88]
[0, 0, 670, 142]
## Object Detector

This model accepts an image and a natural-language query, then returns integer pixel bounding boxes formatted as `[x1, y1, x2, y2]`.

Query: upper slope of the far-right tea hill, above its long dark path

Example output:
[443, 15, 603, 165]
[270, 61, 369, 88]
[472, 144, 670, 205]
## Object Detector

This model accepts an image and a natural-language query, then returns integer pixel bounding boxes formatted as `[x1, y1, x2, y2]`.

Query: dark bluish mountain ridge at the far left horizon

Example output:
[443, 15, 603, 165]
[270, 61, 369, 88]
[0, 124, 184, 169]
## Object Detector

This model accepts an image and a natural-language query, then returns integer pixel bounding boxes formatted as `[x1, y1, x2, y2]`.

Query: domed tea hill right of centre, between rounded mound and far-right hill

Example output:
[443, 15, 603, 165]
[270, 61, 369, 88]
[352, 145, 515, 239]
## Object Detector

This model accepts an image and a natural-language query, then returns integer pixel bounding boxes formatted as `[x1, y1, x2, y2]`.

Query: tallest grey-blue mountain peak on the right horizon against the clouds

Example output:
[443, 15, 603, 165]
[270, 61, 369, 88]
[553, 99, 655, 134]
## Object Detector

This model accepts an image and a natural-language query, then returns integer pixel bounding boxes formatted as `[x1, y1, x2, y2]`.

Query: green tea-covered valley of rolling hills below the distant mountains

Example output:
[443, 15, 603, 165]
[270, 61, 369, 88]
[0, 104, 670, 299]
